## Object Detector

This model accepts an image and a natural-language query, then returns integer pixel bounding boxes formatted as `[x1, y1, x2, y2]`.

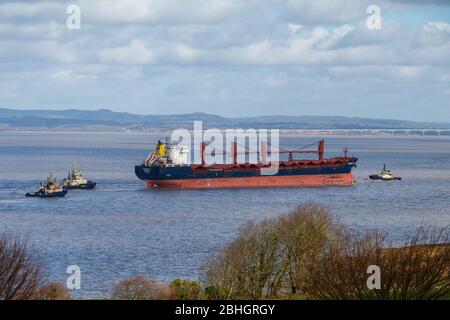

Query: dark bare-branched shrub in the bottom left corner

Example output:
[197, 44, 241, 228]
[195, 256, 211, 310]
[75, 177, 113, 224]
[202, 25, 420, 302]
[0, 234, 45, 300]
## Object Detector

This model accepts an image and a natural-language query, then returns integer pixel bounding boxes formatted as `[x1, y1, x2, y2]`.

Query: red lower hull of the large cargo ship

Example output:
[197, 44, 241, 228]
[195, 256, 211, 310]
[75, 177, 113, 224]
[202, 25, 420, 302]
[146, 173, 355, 189]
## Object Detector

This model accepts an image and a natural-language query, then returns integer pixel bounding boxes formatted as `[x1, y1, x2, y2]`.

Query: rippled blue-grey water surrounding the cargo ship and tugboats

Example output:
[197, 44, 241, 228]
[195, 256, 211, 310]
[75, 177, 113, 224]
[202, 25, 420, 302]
[0, 132, 450, 297]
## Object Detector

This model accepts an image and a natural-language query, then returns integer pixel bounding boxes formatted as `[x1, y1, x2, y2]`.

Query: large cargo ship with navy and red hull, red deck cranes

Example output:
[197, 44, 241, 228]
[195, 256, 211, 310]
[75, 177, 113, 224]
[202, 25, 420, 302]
[135, 140, 358, 189]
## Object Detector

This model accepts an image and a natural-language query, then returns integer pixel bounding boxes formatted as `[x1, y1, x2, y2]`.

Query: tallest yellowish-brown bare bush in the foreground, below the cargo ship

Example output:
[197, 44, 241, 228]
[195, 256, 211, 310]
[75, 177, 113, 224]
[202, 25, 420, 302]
[201, 204, 339, 299]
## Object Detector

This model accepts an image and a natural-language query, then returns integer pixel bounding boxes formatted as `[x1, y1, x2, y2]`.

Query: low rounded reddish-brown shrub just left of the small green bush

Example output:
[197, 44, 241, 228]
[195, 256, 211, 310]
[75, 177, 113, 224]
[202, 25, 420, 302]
[112, 276, 171, 300]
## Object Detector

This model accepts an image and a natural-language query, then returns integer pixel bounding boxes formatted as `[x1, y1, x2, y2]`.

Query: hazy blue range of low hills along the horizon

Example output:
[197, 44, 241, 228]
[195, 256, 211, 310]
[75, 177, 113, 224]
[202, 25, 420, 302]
[0, 108, 450, 130]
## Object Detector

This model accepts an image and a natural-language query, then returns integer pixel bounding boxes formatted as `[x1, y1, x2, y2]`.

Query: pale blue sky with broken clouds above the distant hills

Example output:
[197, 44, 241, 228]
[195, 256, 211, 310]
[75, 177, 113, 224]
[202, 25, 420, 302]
[0, 0, 450, 122]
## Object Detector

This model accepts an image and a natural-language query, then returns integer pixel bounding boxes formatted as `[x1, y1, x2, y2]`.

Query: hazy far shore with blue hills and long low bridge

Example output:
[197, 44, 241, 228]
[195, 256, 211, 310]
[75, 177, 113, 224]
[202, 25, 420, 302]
[0, 108, 450, 135]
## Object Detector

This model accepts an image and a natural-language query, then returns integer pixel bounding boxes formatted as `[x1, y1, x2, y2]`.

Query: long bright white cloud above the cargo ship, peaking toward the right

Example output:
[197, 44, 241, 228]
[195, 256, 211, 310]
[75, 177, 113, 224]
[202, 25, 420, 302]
[198, 25, 405, 66]
